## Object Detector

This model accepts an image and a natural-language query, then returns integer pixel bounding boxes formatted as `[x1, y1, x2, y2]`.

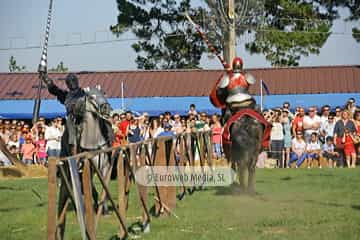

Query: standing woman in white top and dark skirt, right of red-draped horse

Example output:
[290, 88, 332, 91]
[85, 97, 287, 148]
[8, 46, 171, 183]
[270, 113, 284, 168]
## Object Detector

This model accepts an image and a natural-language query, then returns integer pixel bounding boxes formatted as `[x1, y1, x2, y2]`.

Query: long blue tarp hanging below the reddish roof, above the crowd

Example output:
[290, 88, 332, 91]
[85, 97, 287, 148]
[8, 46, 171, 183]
[0, 93, 360, 119]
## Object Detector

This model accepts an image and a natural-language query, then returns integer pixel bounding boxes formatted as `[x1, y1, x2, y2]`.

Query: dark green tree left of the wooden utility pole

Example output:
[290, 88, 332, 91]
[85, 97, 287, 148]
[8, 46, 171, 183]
[110, 0, 205, 69]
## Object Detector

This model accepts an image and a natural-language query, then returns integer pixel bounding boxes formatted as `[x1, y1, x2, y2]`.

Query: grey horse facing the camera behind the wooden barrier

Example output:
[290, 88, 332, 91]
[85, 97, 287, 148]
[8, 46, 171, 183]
[58, 88, 112, 238]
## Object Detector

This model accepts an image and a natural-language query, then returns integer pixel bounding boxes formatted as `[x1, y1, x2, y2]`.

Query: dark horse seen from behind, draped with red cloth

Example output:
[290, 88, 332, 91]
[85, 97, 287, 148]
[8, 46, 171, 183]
[223, 103, 269, 194]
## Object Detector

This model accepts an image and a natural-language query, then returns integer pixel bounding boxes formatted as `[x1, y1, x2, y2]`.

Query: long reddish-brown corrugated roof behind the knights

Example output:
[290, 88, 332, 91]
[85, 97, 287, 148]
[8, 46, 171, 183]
[0, 66, 360, 99]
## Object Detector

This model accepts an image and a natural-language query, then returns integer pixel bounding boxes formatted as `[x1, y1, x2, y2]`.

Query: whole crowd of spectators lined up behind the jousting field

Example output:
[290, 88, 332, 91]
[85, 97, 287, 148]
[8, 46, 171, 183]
[0, 98, 360, 168]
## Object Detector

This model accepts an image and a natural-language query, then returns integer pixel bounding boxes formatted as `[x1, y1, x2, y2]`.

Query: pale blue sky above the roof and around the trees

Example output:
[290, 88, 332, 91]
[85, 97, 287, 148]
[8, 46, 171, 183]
[0, 0, 360, 72]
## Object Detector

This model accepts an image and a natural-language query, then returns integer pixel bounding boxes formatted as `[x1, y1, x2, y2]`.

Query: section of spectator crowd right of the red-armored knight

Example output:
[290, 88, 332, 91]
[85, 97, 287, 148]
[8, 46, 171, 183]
[263, 98, 360, 168]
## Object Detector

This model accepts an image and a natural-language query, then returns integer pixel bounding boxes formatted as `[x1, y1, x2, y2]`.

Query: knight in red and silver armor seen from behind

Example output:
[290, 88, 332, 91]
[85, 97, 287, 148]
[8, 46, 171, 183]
[210, 57, 257, 122]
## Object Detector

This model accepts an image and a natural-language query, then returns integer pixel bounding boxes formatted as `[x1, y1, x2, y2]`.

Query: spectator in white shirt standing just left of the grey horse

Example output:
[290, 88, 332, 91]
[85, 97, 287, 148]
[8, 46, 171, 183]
[45, 118, 62, 157]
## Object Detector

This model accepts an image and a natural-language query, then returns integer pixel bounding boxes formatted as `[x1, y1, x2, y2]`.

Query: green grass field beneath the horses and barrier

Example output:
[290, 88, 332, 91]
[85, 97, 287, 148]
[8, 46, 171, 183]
[0, 168, 360, 240]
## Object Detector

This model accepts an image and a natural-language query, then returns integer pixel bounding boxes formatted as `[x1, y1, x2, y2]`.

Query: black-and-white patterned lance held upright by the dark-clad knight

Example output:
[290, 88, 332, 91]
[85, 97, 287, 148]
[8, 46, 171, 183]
[32, 0, 53, 124]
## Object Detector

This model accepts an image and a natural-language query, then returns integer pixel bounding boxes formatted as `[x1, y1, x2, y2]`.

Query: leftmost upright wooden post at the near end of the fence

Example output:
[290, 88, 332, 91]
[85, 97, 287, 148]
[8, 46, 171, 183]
[47, 157, 56, 240]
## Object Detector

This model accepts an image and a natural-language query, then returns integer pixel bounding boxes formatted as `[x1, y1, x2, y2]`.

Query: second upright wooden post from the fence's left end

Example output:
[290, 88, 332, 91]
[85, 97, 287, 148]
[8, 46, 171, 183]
[82, 158, 96, 240]
